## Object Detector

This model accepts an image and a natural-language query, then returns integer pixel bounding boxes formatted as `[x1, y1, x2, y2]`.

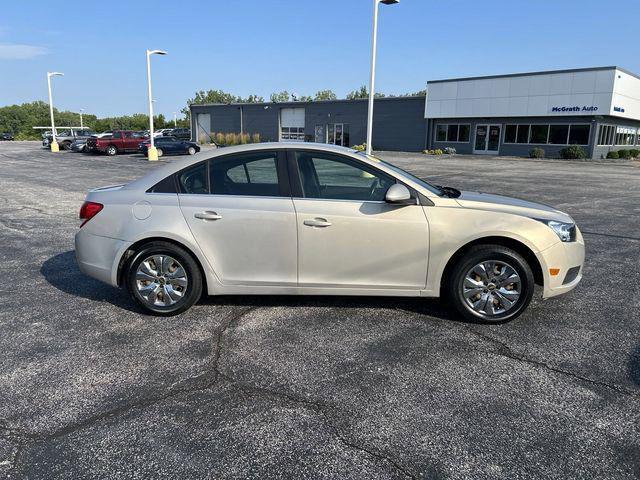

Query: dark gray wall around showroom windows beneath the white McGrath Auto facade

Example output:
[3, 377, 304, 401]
[427, 116, 600, 158]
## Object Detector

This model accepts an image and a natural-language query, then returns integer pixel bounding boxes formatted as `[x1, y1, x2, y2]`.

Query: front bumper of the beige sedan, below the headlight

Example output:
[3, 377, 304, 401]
[539, 229, 585, 298]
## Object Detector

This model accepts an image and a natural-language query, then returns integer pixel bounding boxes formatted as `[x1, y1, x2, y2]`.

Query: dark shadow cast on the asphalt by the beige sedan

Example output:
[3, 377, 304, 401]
[40, 250, 466, 322]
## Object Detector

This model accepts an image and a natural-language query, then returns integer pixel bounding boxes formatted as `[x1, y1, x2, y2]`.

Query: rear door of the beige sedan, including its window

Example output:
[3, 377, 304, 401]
[177, 150, 297, 286]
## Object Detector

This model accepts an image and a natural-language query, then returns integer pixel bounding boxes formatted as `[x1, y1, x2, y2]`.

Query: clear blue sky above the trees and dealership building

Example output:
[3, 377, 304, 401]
[0, 0, 640, 117]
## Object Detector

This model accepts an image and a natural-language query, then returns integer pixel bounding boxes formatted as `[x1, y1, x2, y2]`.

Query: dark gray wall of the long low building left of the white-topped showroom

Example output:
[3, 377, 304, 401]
[191, 97, 426, 151]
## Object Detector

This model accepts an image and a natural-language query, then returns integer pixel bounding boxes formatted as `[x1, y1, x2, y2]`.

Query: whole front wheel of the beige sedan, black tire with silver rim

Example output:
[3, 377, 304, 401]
[445, 245, 535, 323]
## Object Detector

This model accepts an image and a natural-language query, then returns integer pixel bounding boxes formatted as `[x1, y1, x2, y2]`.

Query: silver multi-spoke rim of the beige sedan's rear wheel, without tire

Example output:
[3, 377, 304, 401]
[135, 254, 189, 307]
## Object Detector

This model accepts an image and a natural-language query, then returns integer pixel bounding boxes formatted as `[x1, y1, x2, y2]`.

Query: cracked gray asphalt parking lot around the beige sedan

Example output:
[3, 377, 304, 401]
[0, 142, 640, 479]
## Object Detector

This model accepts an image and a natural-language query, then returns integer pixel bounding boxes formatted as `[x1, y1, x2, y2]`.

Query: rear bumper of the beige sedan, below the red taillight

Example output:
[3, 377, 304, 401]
[75, 229, 131, 287]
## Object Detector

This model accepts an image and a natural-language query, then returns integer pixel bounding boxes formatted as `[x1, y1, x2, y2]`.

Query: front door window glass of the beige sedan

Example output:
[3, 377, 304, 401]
[296, 152, 396, 201]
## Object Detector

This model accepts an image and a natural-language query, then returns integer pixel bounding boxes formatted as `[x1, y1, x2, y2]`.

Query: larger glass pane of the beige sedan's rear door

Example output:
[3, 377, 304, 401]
[209, 152, 280, 197]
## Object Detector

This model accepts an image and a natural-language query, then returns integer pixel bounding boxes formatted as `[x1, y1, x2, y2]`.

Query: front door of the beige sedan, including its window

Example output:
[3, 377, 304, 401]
[289, 150, 429, 290]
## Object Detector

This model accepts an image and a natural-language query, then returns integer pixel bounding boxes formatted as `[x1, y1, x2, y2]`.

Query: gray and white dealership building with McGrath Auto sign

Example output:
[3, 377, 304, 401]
[191, 67, 640, 158]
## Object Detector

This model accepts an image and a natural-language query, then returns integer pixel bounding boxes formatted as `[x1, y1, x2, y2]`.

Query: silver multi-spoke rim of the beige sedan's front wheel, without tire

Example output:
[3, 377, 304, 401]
[461, 260, 522, 317]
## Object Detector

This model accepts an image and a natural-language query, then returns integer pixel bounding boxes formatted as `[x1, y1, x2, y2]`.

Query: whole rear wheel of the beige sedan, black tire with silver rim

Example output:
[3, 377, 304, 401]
[126, 241, 202, 316]
